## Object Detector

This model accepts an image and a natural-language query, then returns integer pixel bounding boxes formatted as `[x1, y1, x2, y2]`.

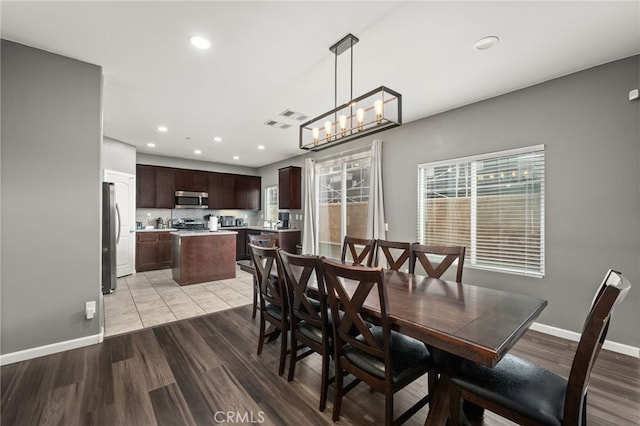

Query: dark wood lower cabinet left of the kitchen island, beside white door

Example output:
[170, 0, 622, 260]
[136, 231, 173, 272]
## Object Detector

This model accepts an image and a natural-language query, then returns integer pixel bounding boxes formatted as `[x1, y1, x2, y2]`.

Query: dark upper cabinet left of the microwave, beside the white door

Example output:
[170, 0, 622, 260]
[136, 164, 175, 209]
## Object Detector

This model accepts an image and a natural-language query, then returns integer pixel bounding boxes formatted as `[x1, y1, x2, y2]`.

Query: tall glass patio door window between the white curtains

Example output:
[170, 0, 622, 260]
[316, 150, 371, 259]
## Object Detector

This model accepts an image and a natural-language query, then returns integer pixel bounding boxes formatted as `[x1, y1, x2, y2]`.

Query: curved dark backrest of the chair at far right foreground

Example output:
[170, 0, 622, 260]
[563, 270, 631, 424]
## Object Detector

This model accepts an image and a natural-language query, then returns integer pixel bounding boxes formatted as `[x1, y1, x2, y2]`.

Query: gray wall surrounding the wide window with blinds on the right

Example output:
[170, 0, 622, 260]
[260, 56, 640, 347]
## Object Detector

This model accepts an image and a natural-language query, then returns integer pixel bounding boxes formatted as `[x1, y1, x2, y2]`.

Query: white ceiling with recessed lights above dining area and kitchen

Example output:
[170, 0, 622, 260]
[0, 1, 640, 167]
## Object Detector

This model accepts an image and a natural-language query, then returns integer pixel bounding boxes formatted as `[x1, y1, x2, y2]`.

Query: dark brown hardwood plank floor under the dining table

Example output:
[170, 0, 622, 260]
[0, 306, 640, 426]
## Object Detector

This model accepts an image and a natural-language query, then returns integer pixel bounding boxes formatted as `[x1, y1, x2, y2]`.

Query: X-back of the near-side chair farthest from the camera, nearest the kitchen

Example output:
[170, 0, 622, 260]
[249, 244, 289, 313]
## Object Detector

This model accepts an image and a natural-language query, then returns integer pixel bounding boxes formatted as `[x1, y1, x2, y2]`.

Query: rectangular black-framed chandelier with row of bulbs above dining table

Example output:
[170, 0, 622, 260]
[300, 34, 402, 151]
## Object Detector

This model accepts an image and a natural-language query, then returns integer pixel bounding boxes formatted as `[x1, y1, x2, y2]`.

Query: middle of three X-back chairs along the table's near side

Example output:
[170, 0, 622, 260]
[278, 250, 333, 411]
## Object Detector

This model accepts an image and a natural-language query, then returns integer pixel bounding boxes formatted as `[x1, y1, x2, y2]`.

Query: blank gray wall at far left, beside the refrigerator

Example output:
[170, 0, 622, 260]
[1, 40, 102, 354]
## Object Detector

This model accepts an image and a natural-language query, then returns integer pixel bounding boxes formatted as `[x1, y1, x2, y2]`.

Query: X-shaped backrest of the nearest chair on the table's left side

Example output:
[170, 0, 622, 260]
[322, 258, 391, 364]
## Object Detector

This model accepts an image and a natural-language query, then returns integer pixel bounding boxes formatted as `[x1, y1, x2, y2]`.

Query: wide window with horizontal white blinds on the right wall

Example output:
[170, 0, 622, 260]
[418, 145, 544, 277]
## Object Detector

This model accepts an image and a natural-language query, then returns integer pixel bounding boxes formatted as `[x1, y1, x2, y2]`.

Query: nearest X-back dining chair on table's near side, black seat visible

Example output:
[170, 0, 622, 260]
[322, 258, 434, 425]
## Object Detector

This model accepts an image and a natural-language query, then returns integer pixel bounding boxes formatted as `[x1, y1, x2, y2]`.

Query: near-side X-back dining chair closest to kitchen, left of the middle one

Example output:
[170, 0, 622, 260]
[249, 244, 289, 375]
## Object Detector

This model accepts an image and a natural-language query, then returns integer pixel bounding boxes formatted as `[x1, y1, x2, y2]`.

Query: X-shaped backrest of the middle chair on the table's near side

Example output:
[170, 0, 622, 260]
[278, 250, 328, 336]
